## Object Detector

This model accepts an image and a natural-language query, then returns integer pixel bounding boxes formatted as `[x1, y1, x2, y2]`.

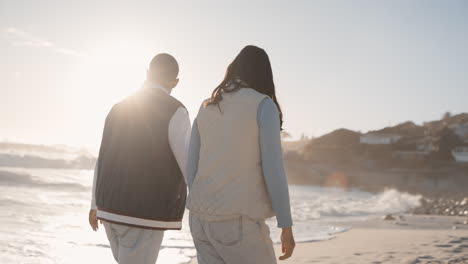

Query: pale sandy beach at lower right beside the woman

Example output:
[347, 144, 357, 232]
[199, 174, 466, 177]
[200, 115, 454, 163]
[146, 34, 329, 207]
[192, 215, 468, 264]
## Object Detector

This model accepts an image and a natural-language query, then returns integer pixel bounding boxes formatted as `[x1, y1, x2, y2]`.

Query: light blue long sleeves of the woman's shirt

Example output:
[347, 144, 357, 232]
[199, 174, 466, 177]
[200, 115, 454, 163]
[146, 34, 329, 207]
[186, 98, 292, 228]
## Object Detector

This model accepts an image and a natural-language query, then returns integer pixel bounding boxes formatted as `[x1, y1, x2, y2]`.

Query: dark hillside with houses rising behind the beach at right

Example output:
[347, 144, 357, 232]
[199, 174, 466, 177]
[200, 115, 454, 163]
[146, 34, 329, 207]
[285, 113, 468, 194]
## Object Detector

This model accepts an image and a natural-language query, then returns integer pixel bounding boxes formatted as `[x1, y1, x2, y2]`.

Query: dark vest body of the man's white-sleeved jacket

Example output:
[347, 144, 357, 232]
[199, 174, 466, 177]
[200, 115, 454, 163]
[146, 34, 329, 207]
[96, 88, 187, 229]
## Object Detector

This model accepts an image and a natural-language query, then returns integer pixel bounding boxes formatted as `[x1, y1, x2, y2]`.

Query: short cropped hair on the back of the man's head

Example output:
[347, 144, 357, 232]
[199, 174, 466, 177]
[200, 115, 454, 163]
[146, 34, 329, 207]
[148, 53, 179, 82]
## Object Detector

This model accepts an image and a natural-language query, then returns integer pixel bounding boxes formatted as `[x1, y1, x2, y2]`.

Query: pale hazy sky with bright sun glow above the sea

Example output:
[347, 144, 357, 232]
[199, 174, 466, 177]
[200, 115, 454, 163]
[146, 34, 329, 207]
[0, 0, 468, 150]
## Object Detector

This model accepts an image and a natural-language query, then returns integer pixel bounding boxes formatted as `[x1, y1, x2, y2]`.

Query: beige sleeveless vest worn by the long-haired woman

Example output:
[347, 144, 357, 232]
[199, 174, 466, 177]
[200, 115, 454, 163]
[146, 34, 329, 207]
[187, 88, 274, 219]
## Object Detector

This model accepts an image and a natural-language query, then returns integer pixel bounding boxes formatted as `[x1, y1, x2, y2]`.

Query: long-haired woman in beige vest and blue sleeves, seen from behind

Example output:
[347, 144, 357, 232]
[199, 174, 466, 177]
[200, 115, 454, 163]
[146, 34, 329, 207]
[187, 46, 295, 264]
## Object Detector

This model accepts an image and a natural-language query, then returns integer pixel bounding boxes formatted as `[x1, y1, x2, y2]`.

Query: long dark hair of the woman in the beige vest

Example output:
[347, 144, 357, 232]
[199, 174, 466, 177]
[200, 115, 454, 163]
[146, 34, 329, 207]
[205, 45, 283, 130]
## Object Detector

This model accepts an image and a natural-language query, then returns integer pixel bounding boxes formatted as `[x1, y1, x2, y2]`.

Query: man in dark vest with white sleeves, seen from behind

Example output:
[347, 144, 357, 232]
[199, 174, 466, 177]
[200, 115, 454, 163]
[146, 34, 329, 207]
[89, 54, 190, 264]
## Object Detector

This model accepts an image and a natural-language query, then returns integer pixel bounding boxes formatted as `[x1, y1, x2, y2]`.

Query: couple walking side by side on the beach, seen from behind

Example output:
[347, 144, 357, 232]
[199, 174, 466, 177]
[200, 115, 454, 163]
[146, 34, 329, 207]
[89, 46, 295, 264]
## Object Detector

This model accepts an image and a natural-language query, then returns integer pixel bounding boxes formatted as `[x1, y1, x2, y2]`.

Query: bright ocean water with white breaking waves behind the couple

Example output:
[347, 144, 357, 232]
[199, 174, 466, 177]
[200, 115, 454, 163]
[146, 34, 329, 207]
[0, 167, 420, 264]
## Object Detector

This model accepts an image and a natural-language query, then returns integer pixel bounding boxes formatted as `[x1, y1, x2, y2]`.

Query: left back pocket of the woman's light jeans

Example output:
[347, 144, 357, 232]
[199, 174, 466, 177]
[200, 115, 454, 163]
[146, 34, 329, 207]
[208, 216, 243, 246]
